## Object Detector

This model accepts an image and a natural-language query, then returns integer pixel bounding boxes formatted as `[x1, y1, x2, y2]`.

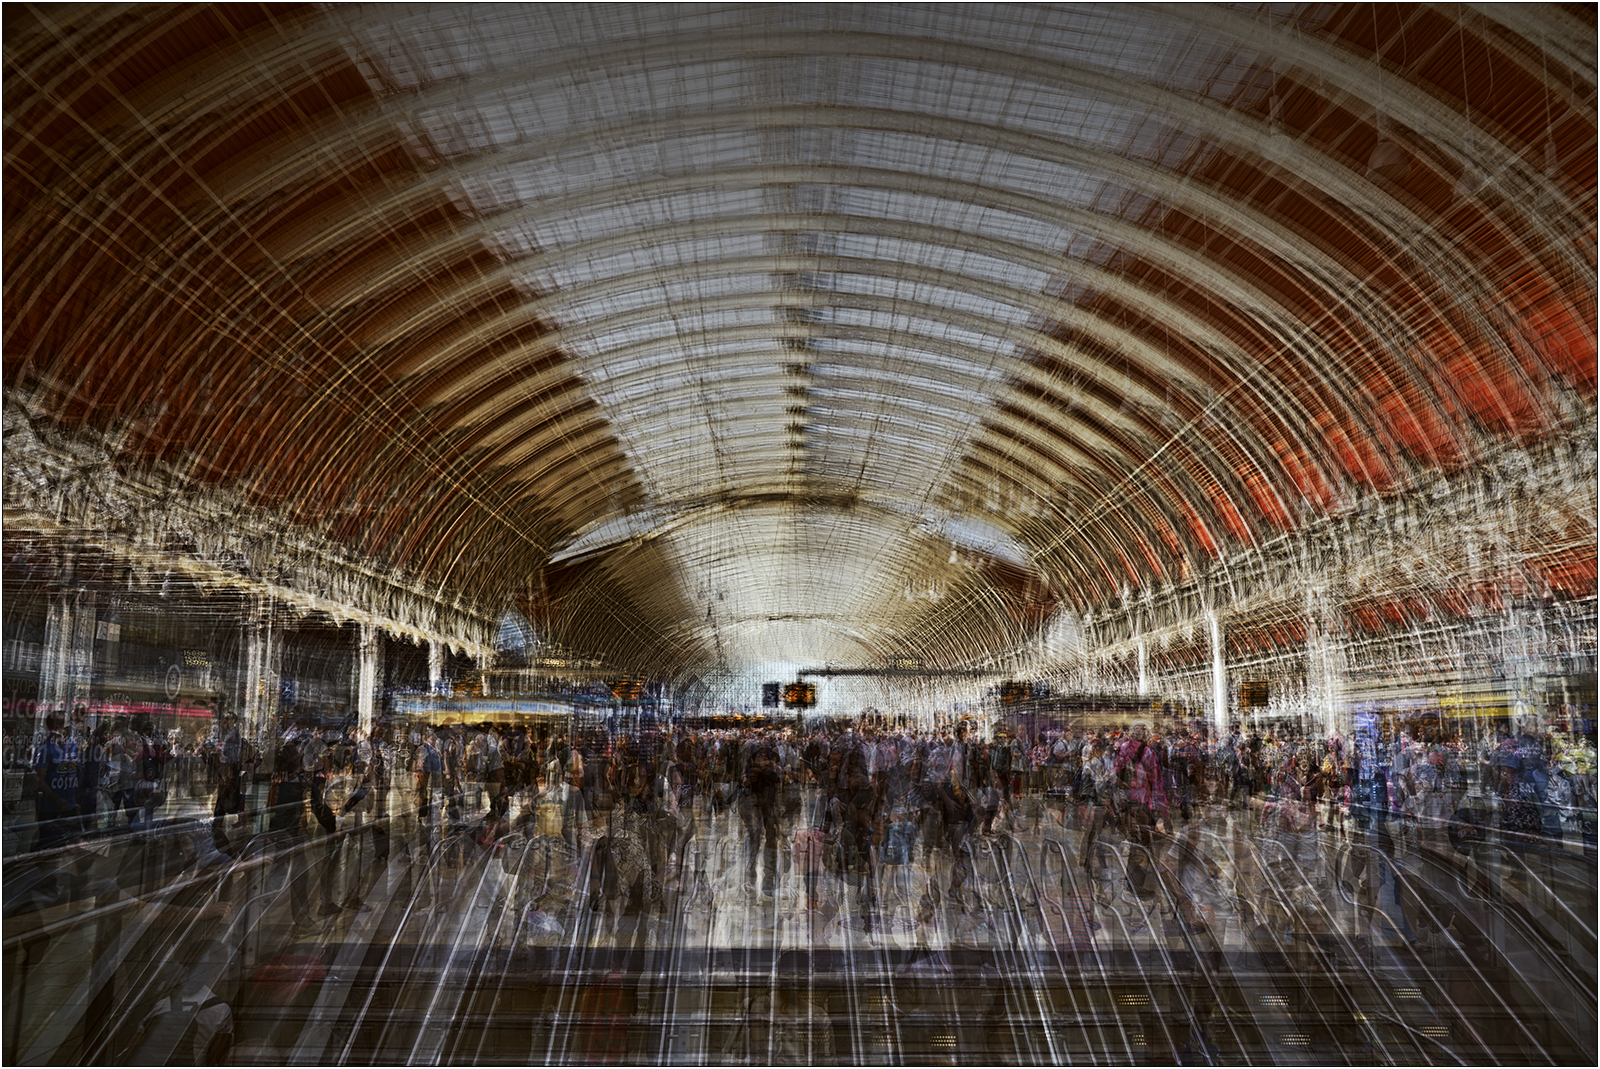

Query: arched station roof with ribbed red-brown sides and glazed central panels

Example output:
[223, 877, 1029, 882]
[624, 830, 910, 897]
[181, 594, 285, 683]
[5, 3, 1597, 671]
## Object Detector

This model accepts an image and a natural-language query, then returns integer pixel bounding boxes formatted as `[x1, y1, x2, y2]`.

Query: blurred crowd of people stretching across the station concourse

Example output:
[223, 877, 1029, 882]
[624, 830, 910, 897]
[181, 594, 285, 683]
[15, 714, 1595, 934]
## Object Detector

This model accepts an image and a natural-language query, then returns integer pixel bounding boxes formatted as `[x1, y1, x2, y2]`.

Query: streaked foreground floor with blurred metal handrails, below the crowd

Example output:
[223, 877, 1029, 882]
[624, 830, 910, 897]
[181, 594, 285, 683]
[3, 780, 1595, 1064]
